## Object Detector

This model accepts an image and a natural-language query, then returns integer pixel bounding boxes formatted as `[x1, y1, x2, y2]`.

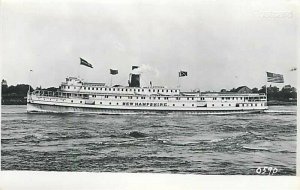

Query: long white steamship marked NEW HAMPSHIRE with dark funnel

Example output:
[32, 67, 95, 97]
[27, 68, 268, 114]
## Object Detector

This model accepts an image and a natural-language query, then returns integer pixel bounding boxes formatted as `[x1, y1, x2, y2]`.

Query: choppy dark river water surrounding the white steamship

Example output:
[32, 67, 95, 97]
[1, 106, 296, 175]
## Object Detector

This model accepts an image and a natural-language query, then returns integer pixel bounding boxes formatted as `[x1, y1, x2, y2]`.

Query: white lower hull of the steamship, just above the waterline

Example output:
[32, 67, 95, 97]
[27, 103, 266, 115]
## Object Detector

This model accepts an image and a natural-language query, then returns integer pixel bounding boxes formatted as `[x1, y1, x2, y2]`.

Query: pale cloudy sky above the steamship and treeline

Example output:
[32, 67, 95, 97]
[0, 0, 299, 91]
